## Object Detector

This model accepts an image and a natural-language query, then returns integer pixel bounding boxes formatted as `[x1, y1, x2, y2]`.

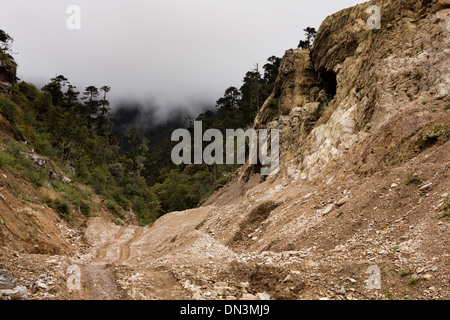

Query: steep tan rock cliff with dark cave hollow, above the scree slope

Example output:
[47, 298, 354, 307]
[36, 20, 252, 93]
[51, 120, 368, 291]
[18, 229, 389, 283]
[251, 0, 450, 182]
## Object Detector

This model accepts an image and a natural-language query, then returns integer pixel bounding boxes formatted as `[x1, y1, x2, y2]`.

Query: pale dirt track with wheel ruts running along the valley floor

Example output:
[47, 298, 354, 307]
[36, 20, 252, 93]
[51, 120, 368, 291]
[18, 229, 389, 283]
[76, 219, 188, 300]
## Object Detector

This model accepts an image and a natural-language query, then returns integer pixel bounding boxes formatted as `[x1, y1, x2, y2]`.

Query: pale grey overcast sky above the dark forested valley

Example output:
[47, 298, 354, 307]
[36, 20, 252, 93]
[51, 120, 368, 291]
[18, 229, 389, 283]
[0, 0, 365, 117]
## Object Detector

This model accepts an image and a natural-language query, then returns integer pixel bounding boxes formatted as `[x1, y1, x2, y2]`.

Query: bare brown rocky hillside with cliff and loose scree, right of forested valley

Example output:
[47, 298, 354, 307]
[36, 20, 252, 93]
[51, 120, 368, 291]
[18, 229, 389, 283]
[0, 0, 450, 300]
